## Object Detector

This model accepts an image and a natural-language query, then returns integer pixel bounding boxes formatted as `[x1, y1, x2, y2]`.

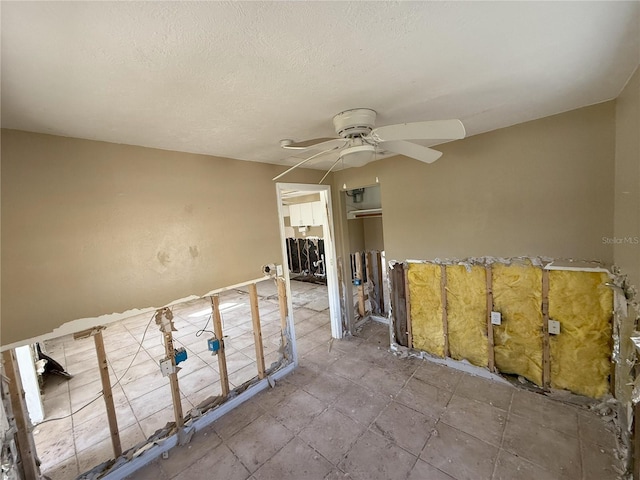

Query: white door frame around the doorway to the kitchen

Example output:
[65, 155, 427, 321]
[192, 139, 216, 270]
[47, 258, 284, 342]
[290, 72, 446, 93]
[276, 183, 344, 364]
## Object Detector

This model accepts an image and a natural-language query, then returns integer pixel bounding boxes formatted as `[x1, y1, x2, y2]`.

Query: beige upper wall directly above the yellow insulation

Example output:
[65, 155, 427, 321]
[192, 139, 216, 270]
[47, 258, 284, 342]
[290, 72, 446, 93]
[333, 102, 615, 262]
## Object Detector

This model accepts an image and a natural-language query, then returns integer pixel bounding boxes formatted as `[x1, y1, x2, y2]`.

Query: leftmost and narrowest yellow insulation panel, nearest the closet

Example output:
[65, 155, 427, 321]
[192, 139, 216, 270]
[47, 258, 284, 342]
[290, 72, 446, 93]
[408, 263, 444, 357]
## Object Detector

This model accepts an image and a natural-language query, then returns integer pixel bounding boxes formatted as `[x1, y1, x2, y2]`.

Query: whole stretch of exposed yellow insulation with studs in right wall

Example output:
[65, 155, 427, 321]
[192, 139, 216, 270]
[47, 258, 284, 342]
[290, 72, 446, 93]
[407, 258, 613, 398]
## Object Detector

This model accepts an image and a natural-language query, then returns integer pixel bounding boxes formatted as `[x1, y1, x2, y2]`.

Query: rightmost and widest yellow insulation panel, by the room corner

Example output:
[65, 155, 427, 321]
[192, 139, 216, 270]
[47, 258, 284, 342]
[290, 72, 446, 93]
[549, 270, 613, 398]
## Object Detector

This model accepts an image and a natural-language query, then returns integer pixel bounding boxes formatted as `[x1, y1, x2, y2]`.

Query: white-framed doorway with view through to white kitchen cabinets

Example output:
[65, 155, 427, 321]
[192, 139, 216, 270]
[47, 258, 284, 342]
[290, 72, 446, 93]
[276, 183, 344, 363]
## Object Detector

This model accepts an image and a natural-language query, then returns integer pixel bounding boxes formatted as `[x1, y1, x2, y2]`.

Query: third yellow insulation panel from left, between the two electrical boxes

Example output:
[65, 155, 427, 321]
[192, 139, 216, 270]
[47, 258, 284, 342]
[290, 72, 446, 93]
[492, 263, 542, 386]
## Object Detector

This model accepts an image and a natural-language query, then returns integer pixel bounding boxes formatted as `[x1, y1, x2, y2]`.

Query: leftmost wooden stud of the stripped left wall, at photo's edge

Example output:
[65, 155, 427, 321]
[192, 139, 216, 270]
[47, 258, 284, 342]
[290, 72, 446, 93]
[2, 349, 40, 479]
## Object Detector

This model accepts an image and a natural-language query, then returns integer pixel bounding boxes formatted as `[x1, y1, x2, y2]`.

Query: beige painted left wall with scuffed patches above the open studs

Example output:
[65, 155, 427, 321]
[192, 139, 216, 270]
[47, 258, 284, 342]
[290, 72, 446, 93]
[0, 130, 318, 345]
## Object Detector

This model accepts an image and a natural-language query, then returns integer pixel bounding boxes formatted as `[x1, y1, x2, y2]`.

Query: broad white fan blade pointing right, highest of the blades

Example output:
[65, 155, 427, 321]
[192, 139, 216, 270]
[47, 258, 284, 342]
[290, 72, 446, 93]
[369, 120, 466, 142]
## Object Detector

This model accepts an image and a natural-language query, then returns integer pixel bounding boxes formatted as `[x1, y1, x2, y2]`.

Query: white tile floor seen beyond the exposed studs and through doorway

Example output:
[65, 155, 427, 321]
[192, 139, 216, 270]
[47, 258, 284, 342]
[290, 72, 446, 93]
[34, 280, 330, 480]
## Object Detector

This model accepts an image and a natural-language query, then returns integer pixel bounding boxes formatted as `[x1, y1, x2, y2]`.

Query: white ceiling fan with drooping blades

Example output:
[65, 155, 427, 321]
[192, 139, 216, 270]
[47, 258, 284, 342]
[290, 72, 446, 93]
[273, 108, 466, 183]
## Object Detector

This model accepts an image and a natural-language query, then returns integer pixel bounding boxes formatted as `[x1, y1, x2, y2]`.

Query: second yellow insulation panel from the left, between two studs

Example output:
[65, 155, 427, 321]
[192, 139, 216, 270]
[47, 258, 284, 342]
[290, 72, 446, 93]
[447, 265, 489, 367]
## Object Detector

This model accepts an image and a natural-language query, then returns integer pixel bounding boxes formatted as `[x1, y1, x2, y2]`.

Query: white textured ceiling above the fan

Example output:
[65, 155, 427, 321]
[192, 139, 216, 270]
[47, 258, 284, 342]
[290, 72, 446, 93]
[1, 1, 640, 171]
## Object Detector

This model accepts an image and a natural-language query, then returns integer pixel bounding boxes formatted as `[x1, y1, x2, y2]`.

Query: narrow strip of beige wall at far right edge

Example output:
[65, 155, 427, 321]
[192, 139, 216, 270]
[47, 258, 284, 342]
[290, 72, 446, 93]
[613, 68, 640, 287]
